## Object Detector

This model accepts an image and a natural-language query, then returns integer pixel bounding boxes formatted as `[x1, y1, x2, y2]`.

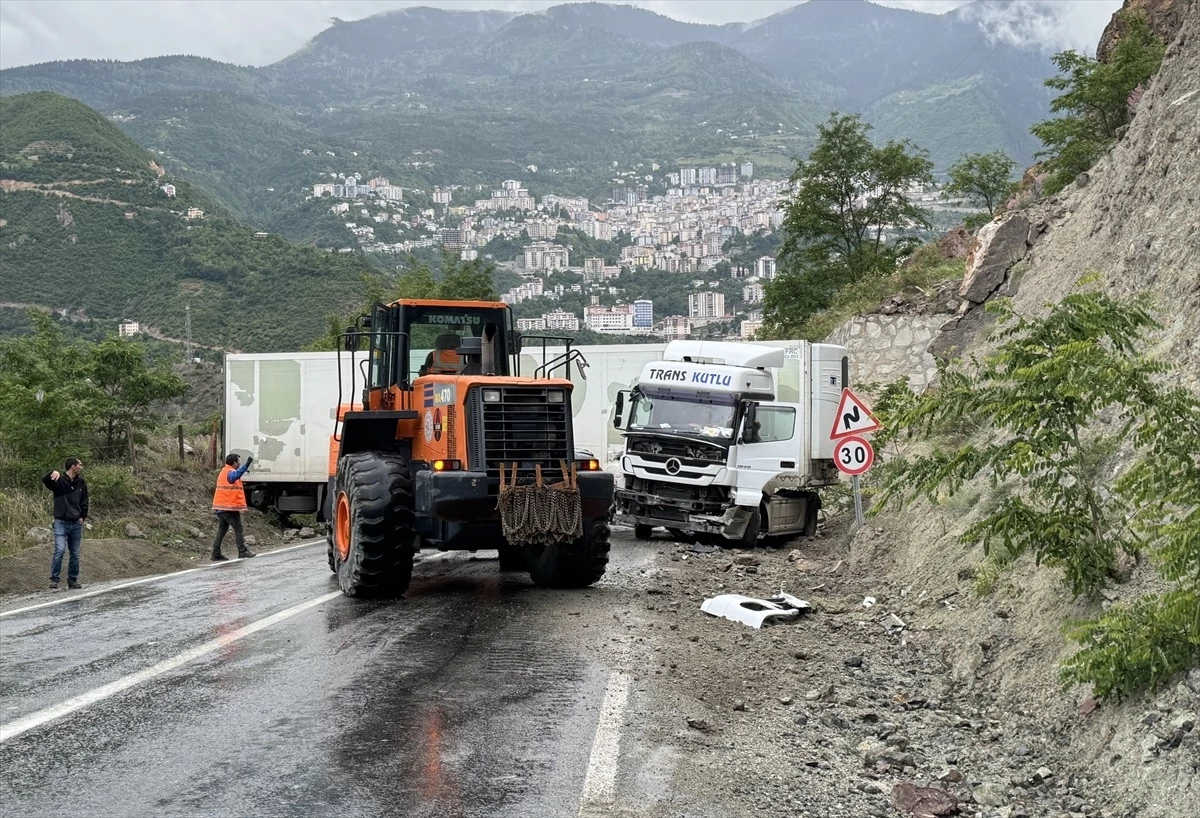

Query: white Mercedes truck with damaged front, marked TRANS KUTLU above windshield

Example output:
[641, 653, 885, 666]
[613, 341, 848, 547]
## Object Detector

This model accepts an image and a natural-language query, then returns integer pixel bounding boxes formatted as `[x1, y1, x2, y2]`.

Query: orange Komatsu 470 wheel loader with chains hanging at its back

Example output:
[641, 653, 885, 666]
[325, 300, 614, 597]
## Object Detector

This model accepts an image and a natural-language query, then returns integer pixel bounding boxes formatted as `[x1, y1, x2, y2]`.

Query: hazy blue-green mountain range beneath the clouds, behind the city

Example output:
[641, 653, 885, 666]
[0, 0, 1052, 237]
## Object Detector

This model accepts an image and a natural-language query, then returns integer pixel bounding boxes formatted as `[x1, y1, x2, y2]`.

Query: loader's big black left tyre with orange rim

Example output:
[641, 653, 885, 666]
[332, 452, 414, 597]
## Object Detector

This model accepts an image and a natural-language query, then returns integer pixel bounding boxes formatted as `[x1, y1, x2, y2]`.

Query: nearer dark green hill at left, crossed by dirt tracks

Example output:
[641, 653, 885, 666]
[0, 92, 372, 351]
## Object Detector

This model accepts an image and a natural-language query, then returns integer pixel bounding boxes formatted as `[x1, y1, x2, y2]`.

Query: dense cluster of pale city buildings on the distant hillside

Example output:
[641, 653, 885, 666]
[304, 162, 806, 338]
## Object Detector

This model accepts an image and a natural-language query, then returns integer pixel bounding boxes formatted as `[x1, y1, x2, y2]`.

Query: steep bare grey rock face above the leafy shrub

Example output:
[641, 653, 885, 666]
[1014, 0, 1200, 387]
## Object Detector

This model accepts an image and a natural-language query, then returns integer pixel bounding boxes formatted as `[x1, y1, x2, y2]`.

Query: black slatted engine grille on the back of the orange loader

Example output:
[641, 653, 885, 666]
[467, 386, 575, 480]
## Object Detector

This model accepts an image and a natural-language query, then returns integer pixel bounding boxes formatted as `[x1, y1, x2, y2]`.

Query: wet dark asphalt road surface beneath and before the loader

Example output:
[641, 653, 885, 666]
[0, 543, 650, 818]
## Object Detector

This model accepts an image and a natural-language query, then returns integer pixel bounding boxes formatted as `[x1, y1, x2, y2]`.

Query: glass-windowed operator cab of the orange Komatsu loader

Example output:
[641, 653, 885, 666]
[364, 300, 517, 409]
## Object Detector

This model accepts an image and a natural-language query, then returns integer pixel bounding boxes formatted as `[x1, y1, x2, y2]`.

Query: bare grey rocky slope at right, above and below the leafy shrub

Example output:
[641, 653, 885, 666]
[836, 0, 1200, 818]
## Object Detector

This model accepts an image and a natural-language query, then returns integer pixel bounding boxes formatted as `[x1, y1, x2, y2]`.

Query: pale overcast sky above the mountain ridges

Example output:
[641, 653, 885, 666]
[0, 0, 1121, 68]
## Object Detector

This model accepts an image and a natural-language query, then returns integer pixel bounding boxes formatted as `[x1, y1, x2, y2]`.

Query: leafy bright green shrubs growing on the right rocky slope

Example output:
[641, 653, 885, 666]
[875, 283, 1200, 699]
